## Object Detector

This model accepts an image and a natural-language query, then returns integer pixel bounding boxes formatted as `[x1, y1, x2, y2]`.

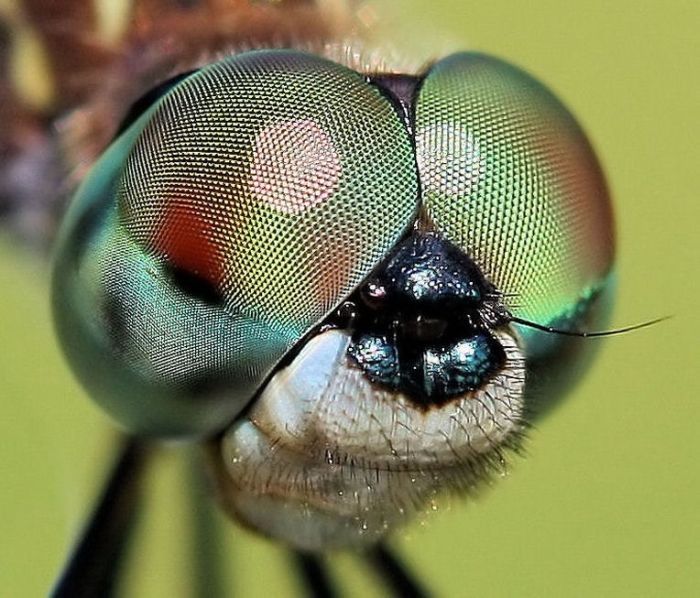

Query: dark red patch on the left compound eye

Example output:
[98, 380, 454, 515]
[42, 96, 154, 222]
[152, 200, 224, 287]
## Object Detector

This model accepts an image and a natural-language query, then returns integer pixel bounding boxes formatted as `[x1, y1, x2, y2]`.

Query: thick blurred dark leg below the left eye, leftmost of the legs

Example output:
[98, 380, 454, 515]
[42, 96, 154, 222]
[51, 437, 148, 598]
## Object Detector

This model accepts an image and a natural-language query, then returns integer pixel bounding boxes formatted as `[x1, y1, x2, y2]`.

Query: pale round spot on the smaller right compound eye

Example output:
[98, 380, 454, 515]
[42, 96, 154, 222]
[416, 122, 486, 197]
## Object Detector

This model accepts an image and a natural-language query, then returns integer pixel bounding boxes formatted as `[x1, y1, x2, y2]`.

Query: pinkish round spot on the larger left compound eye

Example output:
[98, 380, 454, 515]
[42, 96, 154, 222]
[250, 120, 342, 214]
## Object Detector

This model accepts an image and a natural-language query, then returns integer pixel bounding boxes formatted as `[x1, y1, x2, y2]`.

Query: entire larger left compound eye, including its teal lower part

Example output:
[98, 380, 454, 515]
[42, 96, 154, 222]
[54, 51, 418, 436]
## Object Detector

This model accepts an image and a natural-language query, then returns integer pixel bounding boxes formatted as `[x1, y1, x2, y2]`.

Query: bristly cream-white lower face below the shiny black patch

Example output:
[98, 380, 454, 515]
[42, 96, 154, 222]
[217, 330, 525, 550]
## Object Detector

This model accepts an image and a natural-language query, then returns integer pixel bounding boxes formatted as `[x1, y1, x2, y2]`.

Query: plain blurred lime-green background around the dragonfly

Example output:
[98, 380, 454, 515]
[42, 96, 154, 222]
[0, 0, 700, 596]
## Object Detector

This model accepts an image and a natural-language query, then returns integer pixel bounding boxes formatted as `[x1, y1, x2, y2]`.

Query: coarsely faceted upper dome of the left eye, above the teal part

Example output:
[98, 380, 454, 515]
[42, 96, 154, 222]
[117, 51, 417, 339]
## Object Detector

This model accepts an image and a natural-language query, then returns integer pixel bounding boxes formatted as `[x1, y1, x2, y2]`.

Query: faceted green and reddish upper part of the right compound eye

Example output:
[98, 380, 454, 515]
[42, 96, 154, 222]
[416, 53, 614, 357]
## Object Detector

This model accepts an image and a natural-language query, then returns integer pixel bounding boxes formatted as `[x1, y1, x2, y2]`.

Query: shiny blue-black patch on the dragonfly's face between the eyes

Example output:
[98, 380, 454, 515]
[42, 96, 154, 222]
[346, 233, 507, 405]
